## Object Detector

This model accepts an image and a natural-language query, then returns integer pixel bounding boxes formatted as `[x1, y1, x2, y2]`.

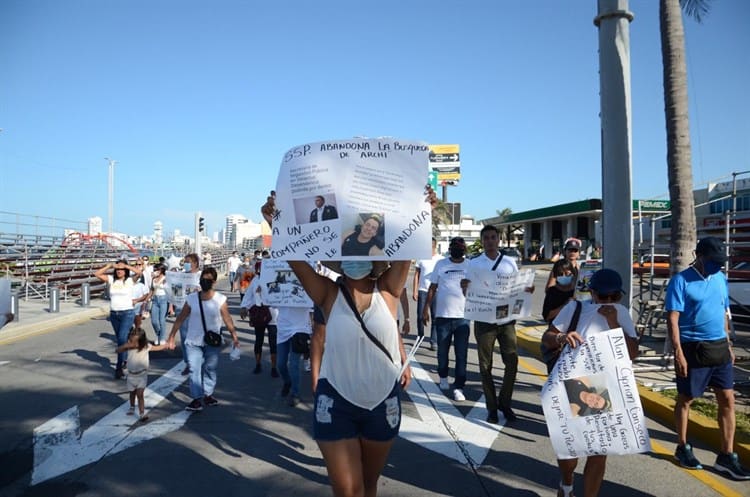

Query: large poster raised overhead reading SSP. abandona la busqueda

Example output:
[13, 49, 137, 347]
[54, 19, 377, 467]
[271, 138, 432, 261]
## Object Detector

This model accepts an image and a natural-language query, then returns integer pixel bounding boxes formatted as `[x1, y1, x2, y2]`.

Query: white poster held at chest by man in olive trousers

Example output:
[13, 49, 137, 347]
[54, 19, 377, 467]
[464, 267, 534, 323]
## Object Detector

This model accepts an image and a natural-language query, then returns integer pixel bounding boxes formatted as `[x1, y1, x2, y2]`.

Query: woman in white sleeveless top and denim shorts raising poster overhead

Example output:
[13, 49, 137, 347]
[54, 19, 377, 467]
[261, 189, 437, 496]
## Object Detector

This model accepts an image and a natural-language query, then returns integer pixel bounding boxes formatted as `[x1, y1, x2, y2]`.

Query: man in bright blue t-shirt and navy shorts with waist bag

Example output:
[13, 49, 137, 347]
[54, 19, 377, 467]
[664, 237, 750, 480]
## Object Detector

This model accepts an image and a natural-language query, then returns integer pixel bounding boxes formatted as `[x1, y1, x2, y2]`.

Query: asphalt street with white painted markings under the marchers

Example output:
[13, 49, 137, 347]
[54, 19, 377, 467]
[0, 267, 750, 497]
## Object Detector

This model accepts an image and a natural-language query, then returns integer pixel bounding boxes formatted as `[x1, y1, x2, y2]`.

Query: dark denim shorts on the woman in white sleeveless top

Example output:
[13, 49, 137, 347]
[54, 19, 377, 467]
[313, 378, 401, 442]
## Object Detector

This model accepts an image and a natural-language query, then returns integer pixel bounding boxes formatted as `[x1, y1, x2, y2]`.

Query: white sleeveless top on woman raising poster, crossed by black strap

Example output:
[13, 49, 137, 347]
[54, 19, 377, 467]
[320, 285, 401, 410]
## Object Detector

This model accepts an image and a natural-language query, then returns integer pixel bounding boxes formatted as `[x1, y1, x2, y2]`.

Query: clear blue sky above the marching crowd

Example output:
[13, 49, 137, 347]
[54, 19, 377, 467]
[0, 0, 750, 235]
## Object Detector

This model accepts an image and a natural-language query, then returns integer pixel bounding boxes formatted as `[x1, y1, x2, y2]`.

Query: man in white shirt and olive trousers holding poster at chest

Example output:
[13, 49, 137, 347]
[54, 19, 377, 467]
[464, 224, 534, 423]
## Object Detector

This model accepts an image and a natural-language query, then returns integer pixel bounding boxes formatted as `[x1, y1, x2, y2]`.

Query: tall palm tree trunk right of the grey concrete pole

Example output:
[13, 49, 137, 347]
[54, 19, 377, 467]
[659, 0, 710, 274]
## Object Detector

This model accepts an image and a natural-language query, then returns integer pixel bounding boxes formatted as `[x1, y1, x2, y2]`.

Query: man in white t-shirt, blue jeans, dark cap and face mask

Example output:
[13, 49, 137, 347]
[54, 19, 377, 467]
[421, 237, 469, 401]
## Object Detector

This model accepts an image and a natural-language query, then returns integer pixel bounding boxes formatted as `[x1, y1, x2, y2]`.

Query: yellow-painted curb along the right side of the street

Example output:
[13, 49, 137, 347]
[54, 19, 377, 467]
[516, 323, 750, 464]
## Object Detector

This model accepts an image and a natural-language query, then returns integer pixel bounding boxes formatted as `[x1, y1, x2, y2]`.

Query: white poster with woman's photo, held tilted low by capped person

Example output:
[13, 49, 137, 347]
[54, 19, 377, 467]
[542, 328, 651, 459]
